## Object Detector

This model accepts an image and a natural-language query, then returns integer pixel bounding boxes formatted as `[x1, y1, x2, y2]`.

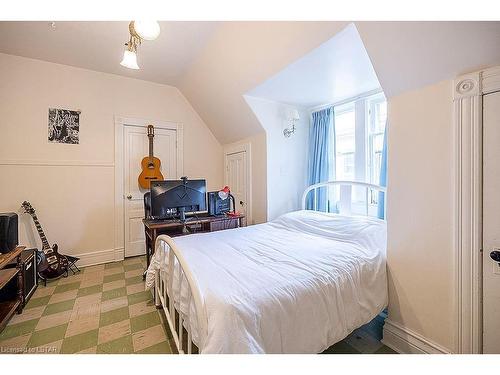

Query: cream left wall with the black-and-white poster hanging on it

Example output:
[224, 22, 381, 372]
[0, 54, 223, 264]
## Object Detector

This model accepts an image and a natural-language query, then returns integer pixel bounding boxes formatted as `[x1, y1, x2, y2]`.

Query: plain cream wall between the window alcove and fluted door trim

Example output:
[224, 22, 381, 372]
[387, 81, 455, 351]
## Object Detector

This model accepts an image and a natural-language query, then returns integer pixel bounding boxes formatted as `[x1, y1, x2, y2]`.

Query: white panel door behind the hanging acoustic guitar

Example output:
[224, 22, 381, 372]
[123, 126, 179, 257]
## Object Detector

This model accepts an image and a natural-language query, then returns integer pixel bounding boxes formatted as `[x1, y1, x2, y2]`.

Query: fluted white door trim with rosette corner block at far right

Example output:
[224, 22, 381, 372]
[453, 66, 500, 353]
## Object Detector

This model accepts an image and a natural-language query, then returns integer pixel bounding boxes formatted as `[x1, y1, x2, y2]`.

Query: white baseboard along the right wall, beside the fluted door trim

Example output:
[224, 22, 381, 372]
[382, 319, 451, 354]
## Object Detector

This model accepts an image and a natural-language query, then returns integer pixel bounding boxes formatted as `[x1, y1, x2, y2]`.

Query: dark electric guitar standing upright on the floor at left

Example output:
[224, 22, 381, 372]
[21, 201, 68, 279]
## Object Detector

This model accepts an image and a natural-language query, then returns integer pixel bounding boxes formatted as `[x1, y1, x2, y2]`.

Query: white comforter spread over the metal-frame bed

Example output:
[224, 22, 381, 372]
[148, 211, 387, 353]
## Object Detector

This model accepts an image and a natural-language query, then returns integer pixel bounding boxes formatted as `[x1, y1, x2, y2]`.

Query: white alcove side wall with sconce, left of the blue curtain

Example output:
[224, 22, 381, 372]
[245, 96, 309, 220]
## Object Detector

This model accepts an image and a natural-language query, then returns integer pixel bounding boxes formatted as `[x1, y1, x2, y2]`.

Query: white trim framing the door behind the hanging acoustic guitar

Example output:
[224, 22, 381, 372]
[114, 115, 184, 261]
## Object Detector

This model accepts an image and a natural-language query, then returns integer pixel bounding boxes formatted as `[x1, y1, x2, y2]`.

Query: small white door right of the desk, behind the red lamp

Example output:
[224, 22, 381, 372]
[225, 151, 248, 220]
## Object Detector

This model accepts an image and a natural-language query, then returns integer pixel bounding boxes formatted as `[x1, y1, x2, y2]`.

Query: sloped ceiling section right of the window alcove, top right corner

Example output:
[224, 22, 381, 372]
[355, 22, 500, 97]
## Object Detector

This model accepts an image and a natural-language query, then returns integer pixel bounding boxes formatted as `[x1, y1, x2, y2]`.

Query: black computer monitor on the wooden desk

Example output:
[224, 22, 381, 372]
[151, 177, 207, 221]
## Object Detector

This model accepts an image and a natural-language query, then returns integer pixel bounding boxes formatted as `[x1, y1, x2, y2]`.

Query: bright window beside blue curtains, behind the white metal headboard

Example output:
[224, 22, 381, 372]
[329, 93, 387, 213]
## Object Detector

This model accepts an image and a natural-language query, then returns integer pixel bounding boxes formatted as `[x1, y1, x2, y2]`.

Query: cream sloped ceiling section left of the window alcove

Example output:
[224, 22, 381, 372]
[179, 22, 347, 143]
